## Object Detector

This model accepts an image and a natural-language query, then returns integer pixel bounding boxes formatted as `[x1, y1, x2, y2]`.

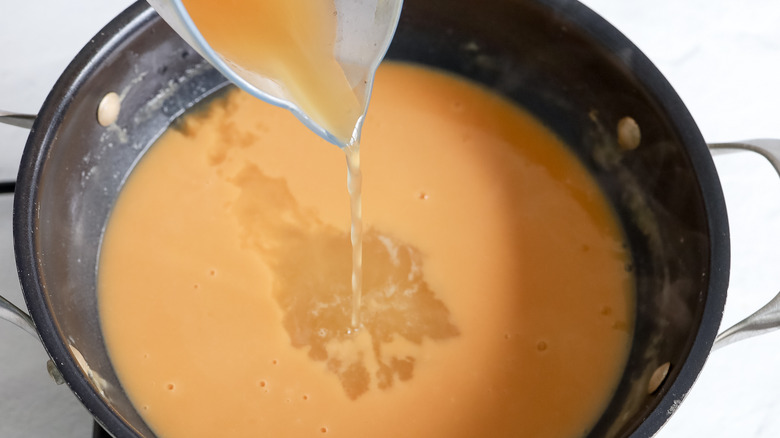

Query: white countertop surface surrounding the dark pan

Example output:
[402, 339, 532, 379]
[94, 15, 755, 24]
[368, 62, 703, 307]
[0, 0, 780, 438]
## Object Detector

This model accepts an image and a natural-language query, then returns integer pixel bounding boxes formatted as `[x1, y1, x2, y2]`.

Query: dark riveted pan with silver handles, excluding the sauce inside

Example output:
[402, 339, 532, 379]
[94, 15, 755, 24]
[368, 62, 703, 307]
[0, 0, 780, 437]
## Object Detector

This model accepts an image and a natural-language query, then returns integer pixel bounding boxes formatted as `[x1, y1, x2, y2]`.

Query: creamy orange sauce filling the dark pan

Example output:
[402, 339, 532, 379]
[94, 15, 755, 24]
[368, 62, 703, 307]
[98, 64, 633, 438]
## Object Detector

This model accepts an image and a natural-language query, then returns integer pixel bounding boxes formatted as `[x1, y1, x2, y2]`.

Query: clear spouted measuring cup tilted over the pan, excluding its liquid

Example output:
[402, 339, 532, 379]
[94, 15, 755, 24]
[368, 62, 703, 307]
[147, 0, 403, 147]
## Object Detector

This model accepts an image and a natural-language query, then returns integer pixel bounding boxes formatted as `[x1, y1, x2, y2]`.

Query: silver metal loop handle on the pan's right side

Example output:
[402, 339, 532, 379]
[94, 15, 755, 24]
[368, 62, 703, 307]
[709, 139, 780, 350]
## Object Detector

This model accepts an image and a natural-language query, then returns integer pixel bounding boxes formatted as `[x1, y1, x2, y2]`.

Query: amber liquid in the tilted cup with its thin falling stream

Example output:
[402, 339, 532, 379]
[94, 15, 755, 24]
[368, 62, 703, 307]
[182, 0, 367, 328]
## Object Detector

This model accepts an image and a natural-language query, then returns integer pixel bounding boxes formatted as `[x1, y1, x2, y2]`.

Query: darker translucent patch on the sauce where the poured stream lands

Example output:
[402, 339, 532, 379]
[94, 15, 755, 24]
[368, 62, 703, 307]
[225, 164, 459, 399]
